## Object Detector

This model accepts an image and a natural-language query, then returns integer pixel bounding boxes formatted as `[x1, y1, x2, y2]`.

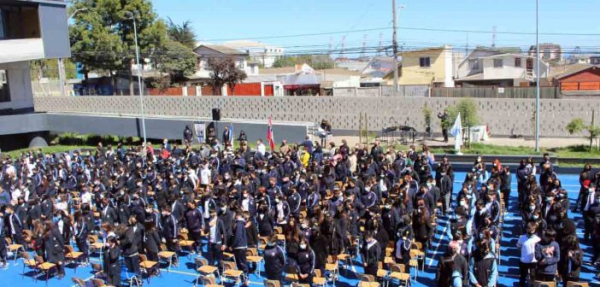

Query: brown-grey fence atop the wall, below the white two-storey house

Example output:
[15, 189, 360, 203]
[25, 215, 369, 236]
[431, 87, 561, 99]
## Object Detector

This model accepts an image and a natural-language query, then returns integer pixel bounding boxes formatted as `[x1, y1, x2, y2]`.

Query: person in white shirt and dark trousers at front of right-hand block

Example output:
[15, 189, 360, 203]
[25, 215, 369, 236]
[517, 222, 541, 287]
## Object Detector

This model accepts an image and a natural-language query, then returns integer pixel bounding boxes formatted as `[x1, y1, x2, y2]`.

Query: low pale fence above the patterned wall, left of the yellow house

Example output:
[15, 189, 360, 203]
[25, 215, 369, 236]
[333, 85, 429, 98]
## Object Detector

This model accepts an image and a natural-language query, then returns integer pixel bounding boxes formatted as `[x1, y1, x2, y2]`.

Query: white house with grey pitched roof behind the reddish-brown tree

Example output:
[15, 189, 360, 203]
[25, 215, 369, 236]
[188, 44, 259, 83]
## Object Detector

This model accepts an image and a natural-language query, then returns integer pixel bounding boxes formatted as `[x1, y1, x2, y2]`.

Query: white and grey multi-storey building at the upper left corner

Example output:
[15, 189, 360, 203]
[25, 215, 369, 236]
[0, 0, 71, 114]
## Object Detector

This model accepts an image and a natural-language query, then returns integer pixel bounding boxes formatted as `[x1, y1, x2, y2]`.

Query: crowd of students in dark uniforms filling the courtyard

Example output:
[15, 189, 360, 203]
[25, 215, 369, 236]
[0, 129, 600, 287]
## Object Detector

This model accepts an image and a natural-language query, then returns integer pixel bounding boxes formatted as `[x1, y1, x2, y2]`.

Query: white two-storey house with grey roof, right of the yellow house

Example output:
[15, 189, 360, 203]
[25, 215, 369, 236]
[456, 54, 549, 87]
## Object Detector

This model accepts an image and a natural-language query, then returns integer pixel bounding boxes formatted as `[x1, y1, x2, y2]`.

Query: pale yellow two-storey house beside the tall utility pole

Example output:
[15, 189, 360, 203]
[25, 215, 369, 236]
[399, 45, 456, 87]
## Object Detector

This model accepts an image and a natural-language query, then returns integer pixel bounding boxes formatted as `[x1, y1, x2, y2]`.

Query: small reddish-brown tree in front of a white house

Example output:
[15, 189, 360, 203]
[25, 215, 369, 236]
[207, 57, 248, 95]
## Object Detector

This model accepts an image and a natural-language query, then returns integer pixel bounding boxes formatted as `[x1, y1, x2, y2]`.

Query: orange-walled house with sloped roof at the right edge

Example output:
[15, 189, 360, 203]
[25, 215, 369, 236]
[554, 65, 600, 93]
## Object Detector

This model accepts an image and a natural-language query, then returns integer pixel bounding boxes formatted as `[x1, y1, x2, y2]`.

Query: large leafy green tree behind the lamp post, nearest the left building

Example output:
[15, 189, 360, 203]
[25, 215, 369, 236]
[69, 0, 167, 95]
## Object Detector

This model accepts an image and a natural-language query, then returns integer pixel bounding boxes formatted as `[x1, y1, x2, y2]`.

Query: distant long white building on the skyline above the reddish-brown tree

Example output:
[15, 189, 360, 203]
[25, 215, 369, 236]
[223, 40, 285, 68]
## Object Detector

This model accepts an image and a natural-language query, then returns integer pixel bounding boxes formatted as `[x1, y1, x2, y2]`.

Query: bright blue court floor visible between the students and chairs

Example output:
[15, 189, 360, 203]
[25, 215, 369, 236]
[0, 172, 600, 287]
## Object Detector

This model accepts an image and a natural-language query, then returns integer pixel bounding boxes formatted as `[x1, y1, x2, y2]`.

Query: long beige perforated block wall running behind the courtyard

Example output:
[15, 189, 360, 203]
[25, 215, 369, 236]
[35, 96, 600, 137]
